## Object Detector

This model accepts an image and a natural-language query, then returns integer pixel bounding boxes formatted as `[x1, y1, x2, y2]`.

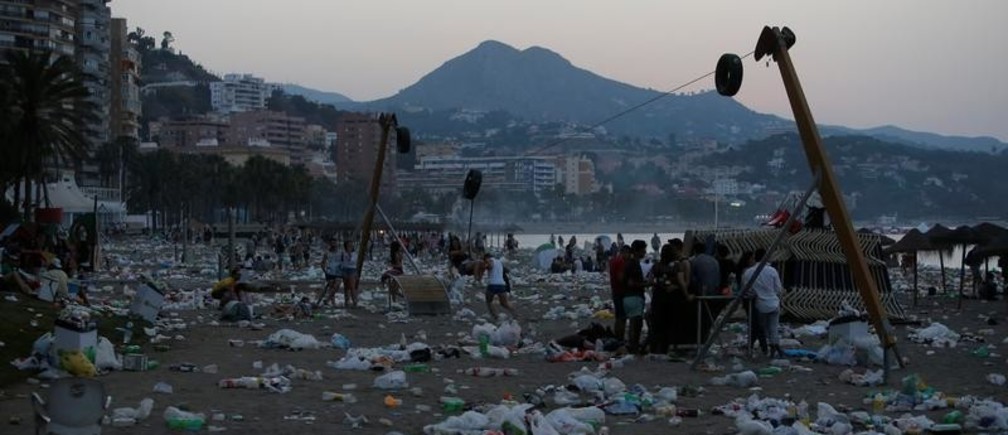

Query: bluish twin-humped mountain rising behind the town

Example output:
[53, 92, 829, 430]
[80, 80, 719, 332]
[355, 40, 791, 142]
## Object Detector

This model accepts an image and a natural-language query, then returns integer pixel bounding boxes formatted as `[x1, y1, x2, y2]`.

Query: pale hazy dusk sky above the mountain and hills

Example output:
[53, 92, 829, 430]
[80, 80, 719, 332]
[111, 0, 1008, 141]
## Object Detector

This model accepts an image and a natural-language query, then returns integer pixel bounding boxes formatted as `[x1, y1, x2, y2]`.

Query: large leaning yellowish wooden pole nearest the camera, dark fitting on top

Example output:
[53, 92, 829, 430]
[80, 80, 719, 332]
[754, 26, 902, 368]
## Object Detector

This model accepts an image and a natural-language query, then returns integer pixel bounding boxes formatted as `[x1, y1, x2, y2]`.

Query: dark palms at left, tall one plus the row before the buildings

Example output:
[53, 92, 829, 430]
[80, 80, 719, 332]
[0, 50, 342, 227]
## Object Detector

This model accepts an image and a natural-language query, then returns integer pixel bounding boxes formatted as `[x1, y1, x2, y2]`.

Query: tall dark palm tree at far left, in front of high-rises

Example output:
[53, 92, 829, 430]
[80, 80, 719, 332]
[3, 50, 96, 221]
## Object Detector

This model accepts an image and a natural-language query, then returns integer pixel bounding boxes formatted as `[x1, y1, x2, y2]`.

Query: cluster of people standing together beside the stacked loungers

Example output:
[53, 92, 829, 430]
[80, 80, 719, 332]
[608, 239, 783, 356]
